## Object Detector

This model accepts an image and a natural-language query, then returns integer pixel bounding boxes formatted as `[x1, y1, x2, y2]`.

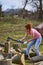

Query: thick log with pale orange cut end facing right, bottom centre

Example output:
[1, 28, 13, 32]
[12, 54, 25, 65]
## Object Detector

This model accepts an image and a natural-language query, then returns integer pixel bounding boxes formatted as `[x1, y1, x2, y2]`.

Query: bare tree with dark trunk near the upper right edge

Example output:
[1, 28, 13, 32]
[31, 0, 42, 20]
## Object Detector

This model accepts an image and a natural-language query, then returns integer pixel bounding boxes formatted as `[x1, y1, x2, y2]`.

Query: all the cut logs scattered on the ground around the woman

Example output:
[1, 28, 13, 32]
[0, 40, 43, 65]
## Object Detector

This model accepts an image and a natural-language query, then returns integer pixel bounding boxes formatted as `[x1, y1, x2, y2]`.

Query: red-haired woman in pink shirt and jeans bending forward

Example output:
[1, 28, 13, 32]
[19, 23, 42, 59]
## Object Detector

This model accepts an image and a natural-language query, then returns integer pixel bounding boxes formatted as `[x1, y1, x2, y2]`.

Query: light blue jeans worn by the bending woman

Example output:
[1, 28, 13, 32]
[26, 37, 42, 55]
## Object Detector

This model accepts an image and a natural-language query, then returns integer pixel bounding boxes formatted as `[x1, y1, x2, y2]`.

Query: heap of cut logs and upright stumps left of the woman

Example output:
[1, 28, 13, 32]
[0, 40, 25, 65]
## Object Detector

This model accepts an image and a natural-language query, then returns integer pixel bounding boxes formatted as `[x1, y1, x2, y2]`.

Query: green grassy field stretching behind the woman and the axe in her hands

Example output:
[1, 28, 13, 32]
[0, 17, 41, 41]
